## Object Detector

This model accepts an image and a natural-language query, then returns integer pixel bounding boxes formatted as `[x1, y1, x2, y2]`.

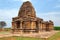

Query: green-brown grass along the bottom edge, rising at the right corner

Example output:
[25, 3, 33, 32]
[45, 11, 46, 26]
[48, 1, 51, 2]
[0, 32, 60, 40]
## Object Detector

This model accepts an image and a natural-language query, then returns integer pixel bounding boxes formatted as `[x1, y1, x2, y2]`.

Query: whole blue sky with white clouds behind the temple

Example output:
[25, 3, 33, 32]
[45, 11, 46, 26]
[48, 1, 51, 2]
[0, 0, 60, 27]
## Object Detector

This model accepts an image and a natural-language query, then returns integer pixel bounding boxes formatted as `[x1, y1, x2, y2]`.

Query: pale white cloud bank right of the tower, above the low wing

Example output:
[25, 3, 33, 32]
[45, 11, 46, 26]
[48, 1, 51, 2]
[37, 12, 60, 26]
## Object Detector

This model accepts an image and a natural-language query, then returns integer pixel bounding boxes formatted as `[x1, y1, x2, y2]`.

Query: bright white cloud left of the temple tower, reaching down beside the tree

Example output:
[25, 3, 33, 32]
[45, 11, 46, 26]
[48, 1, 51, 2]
[0, 9, 18, 27]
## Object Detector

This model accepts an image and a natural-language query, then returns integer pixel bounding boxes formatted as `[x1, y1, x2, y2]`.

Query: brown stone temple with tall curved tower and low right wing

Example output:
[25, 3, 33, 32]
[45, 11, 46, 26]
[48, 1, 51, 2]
[12, 1, 54, 33]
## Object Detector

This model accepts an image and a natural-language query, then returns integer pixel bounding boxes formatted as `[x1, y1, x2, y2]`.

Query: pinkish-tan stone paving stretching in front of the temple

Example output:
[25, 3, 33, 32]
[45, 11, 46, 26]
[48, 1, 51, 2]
[0, 31, 59, 38]
